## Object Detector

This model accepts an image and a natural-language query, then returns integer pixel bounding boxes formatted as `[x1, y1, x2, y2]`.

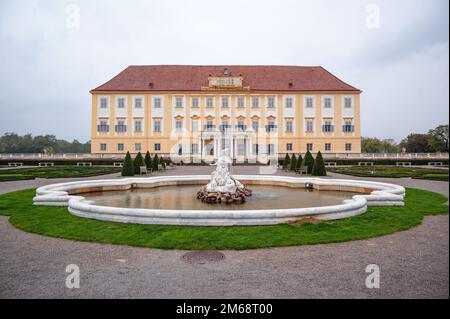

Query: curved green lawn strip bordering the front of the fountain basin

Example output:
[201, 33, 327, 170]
[0, 188, 448, 249]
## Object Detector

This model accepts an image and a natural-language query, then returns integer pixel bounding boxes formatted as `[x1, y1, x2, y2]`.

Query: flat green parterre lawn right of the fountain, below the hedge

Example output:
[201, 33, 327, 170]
[328, 166, 448, 181]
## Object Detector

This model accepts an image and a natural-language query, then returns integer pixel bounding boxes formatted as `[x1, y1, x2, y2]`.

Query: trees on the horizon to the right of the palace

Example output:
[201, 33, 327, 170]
[361, 125, 449, 153]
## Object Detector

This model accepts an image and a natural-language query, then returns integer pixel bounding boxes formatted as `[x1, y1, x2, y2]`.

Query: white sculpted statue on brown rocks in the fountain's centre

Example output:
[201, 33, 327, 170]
[197, 148, 252, 204]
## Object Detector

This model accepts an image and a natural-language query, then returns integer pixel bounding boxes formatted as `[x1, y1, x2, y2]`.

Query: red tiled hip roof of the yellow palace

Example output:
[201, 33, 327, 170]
[91, 65, 361, 93]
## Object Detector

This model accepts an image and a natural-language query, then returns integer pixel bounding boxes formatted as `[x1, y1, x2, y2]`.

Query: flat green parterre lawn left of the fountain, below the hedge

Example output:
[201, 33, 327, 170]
[0, 166, 120, 182]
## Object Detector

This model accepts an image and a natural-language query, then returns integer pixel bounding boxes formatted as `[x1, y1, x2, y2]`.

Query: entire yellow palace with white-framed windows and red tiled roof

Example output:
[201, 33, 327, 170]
[90, 65, 361, 162]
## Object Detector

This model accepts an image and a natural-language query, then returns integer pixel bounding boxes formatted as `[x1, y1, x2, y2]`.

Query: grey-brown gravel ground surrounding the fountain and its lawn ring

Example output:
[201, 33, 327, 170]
[0, 167, 449, 298]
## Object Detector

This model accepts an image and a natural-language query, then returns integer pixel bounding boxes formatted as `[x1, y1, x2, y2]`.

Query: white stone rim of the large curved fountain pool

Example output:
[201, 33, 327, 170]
[33, 175, 405, 226]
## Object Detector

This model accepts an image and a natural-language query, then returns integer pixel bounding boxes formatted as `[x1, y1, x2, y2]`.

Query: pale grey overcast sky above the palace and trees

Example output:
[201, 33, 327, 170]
[0, 0, 449, 141]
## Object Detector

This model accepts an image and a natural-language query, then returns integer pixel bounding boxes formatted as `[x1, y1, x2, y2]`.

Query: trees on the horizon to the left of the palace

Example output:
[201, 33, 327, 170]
[0, 133, 91, 154]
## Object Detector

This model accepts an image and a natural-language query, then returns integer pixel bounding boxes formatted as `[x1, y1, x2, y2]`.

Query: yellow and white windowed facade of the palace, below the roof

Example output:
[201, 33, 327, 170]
[92, 90, 361, 162]
